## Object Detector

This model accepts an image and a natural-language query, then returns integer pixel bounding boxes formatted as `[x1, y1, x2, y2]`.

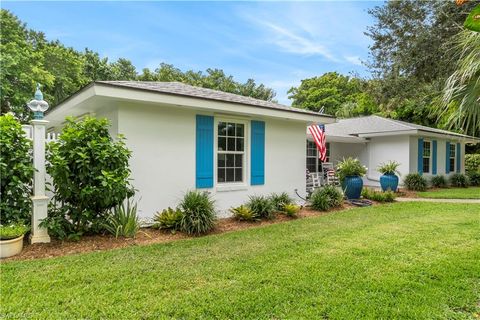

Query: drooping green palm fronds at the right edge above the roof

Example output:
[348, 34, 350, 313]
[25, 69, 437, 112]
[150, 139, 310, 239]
[441, 30, 480, 137]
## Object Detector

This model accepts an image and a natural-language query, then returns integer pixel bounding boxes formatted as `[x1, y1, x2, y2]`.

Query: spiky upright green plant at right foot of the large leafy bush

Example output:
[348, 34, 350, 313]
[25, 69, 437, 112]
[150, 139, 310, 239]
[104, 199, 140, 238]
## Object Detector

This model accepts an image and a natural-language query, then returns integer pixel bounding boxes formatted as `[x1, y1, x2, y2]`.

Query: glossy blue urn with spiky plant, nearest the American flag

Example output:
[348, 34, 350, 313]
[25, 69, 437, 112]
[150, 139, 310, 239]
[337, 157, 367, 199]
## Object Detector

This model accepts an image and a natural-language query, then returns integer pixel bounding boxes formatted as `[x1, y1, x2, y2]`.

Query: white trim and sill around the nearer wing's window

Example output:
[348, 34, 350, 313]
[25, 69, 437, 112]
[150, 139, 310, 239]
[213, 117, 250, 191]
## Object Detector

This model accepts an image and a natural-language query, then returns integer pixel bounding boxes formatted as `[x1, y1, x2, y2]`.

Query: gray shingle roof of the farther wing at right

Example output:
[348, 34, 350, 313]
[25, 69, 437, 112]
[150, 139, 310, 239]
[325, 115, 478, 138]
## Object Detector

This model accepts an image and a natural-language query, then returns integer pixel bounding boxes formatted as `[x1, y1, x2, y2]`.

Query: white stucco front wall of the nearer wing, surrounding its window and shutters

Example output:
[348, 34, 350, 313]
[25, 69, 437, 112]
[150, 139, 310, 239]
[118, 105, 306, 218]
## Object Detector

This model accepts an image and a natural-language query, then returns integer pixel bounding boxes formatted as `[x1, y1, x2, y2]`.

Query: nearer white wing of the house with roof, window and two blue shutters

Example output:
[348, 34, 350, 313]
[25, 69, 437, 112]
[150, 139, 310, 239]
[46, 81, 335, 218]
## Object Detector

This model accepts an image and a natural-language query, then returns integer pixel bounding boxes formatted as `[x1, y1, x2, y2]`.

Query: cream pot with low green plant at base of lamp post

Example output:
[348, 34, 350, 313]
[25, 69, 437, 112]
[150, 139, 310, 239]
[0, 223, 30, 258]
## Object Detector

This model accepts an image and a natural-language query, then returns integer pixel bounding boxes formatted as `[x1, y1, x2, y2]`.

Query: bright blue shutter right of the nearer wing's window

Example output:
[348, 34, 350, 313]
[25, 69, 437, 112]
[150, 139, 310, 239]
[250, 121, 265, 185]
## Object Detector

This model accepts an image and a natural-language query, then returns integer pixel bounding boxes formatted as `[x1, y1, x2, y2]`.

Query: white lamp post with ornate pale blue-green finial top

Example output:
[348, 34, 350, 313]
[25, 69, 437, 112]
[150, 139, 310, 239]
[28, 84, 50, 243]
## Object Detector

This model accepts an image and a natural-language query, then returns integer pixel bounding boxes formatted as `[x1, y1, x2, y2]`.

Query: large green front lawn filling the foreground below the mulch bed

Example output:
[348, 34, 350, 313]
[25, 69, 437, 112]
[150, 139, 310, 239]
[1, 203, 480, 319]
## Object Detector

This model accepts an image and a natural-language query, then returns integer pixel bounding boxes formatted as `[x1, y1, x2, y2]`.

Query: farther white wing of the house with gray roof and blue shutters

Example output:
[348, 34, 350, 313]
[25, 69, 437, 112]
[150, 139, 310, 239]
[306, 115, 480, 186]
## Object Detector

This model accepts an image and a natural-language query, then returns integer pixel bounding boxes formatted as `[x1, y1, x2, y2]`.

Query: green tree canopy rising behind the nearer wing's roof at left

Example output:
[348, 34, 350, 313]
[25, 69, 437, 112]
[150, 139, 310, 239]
[0, 9, 275, 121]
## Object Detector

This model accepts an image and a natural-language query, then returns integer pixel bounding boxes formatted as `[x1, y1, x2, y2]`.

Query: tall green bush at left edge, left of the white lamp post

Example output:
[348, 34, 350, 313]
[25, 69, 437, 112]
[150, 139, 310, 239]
[0, 114, 33, 225]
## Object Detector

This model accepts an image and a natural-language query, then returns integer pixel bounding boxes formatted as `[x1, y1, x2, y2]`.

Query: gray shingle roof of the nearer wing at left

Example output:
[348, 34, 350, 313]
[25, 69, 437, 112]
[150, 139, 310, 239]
[95, 81, 333, 118]
